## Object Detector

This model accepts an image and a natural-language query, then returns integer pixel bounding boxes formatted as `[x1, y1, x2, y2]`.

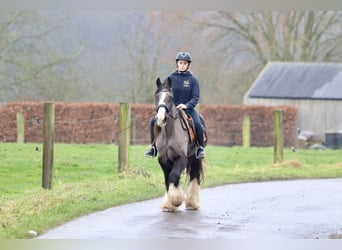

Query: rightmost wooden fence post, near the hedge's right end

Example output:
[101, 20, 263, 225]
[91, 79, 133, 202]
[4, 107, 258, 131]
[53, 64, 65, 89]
[273, 110, 284, 163]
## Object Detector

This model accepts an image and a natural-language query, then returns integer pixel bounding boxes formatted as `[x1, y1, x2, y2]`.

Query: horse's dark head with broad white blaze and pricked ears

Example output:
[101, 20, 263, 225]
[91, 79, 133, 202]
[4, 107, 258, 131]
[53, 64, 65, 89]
[155, 77, 173, 127]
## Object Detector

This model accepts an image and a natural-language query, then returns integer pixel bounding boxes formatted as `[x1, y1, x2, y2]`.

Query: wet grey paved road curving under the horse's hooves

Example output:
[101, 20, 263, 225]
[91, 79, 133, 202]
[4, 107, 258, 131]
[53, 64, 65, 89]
[38, 179, 342, 239]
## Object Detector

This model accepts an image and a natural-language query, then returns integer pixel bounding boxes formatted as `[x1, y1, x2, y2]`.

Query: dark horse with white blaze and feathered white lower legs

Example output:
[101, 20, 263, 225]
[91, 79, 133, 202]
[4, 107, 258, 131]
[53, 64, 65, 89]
[155, 78, 205, 212]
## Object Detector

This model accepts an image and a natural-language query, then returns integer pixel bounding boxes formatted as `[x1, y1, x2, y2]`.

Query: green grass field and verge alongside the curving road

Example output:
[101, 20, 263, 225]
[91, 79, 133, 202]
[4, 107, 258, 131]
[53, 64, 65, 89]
[0, 143, 342, 239]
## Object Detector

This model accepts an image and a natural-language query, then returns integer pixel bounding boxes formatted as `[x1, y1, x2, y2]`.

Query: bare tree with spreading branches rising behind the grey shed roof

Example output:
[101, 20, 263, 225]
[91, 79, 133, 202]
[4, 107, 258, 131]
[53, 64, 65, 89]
[187, 11, 342, 68]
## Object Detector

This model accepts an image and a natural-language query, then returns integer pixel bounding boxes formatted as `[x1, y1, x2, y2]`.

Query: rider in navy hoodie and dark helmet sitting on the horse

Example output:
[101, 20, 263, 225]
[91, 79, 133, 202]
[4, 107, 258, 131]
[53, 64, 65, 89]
[145, 52, 205, 158]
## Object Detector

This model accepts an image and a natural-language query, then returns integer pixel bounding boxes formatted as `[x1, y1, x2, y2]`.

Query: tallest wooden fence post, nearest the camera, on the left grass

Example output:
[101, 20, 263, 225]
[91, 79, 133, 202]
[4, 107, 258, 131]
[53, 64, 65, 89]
[42, 103, 55, 189]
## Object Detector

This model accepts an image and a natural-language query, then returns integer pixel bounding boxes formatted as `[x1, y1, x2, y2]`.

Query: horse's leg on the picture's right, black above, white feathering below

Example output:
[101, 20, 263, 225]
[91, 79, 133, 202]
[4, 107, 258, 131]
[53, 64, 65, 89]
[185, 159, 202, 210]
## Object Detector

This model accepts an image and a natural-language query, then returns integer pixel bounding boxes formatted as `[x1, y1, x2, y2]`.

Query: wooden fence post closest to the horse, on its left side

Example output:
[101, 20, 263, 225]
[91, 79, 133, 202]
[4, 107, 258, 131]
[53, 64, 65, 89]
[118, 103, 131, 172]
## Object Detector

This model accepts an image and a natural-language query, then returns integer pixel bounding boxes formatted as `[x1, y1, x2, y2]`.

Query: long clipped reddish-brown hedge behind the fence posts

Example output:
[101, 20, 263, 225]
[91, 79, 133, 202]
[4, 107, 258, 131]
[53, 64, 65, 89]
[0, 102, 297, 146]
